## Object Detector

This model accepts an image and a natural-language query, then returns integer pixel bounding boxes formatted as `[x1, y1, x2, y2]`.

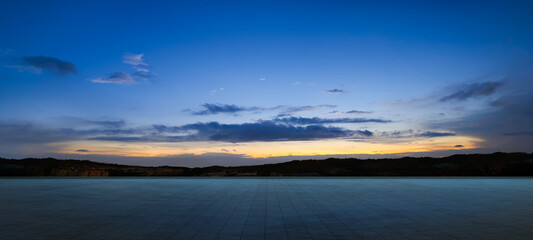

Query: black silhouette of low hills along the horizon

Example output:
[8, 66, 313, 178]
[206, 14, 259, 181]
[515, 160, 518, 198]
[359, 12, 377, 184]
[0, 152, 533, 177]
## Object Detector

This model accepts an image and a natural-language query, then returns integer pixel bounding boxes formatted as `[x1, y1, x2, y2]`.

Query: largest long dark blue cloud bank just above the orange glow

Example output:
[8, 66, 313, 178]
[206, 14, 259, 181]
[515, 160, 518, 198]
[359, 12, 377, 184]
[88, 121, 373, 143]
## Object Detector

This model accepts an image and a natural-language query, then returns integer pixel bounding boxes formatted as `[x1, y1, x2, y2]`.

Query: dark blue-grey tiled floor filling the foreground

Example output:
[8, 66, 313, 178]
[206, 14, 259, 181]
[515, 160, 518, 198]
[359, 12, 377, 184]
[0, 178, 533, 240]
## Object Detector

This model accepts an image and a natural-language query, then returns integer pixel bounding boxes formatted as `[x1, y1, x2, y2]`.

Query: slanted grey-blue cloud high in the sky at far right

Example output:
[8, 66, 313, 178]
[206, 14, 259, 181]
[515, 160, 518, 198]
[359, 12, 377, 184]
[440, 81, 504, 102]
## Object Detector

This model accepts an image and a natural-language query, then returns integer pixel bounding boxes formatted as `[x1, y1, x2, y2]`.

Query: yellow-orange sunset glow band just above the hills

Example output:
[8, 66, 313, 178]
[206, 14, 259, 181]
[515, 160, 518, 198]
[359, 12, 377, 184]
[51, 136, 483, 158]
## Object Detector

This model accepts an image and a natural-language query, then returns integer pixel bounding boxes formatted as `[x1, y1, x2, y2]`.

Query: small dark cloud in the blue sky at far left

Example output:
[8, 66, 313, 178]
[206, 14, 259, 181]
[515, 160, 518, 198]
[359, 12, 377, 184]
[22, 56, 76, 75]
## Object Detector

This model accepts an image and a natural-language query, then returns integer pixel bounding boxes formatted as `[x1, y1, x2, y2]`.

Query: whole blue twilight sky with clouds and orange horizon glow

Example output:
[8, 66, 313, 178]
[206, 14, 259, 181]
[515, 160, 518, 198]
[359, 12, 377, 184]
[0, 0, 533, 167]
